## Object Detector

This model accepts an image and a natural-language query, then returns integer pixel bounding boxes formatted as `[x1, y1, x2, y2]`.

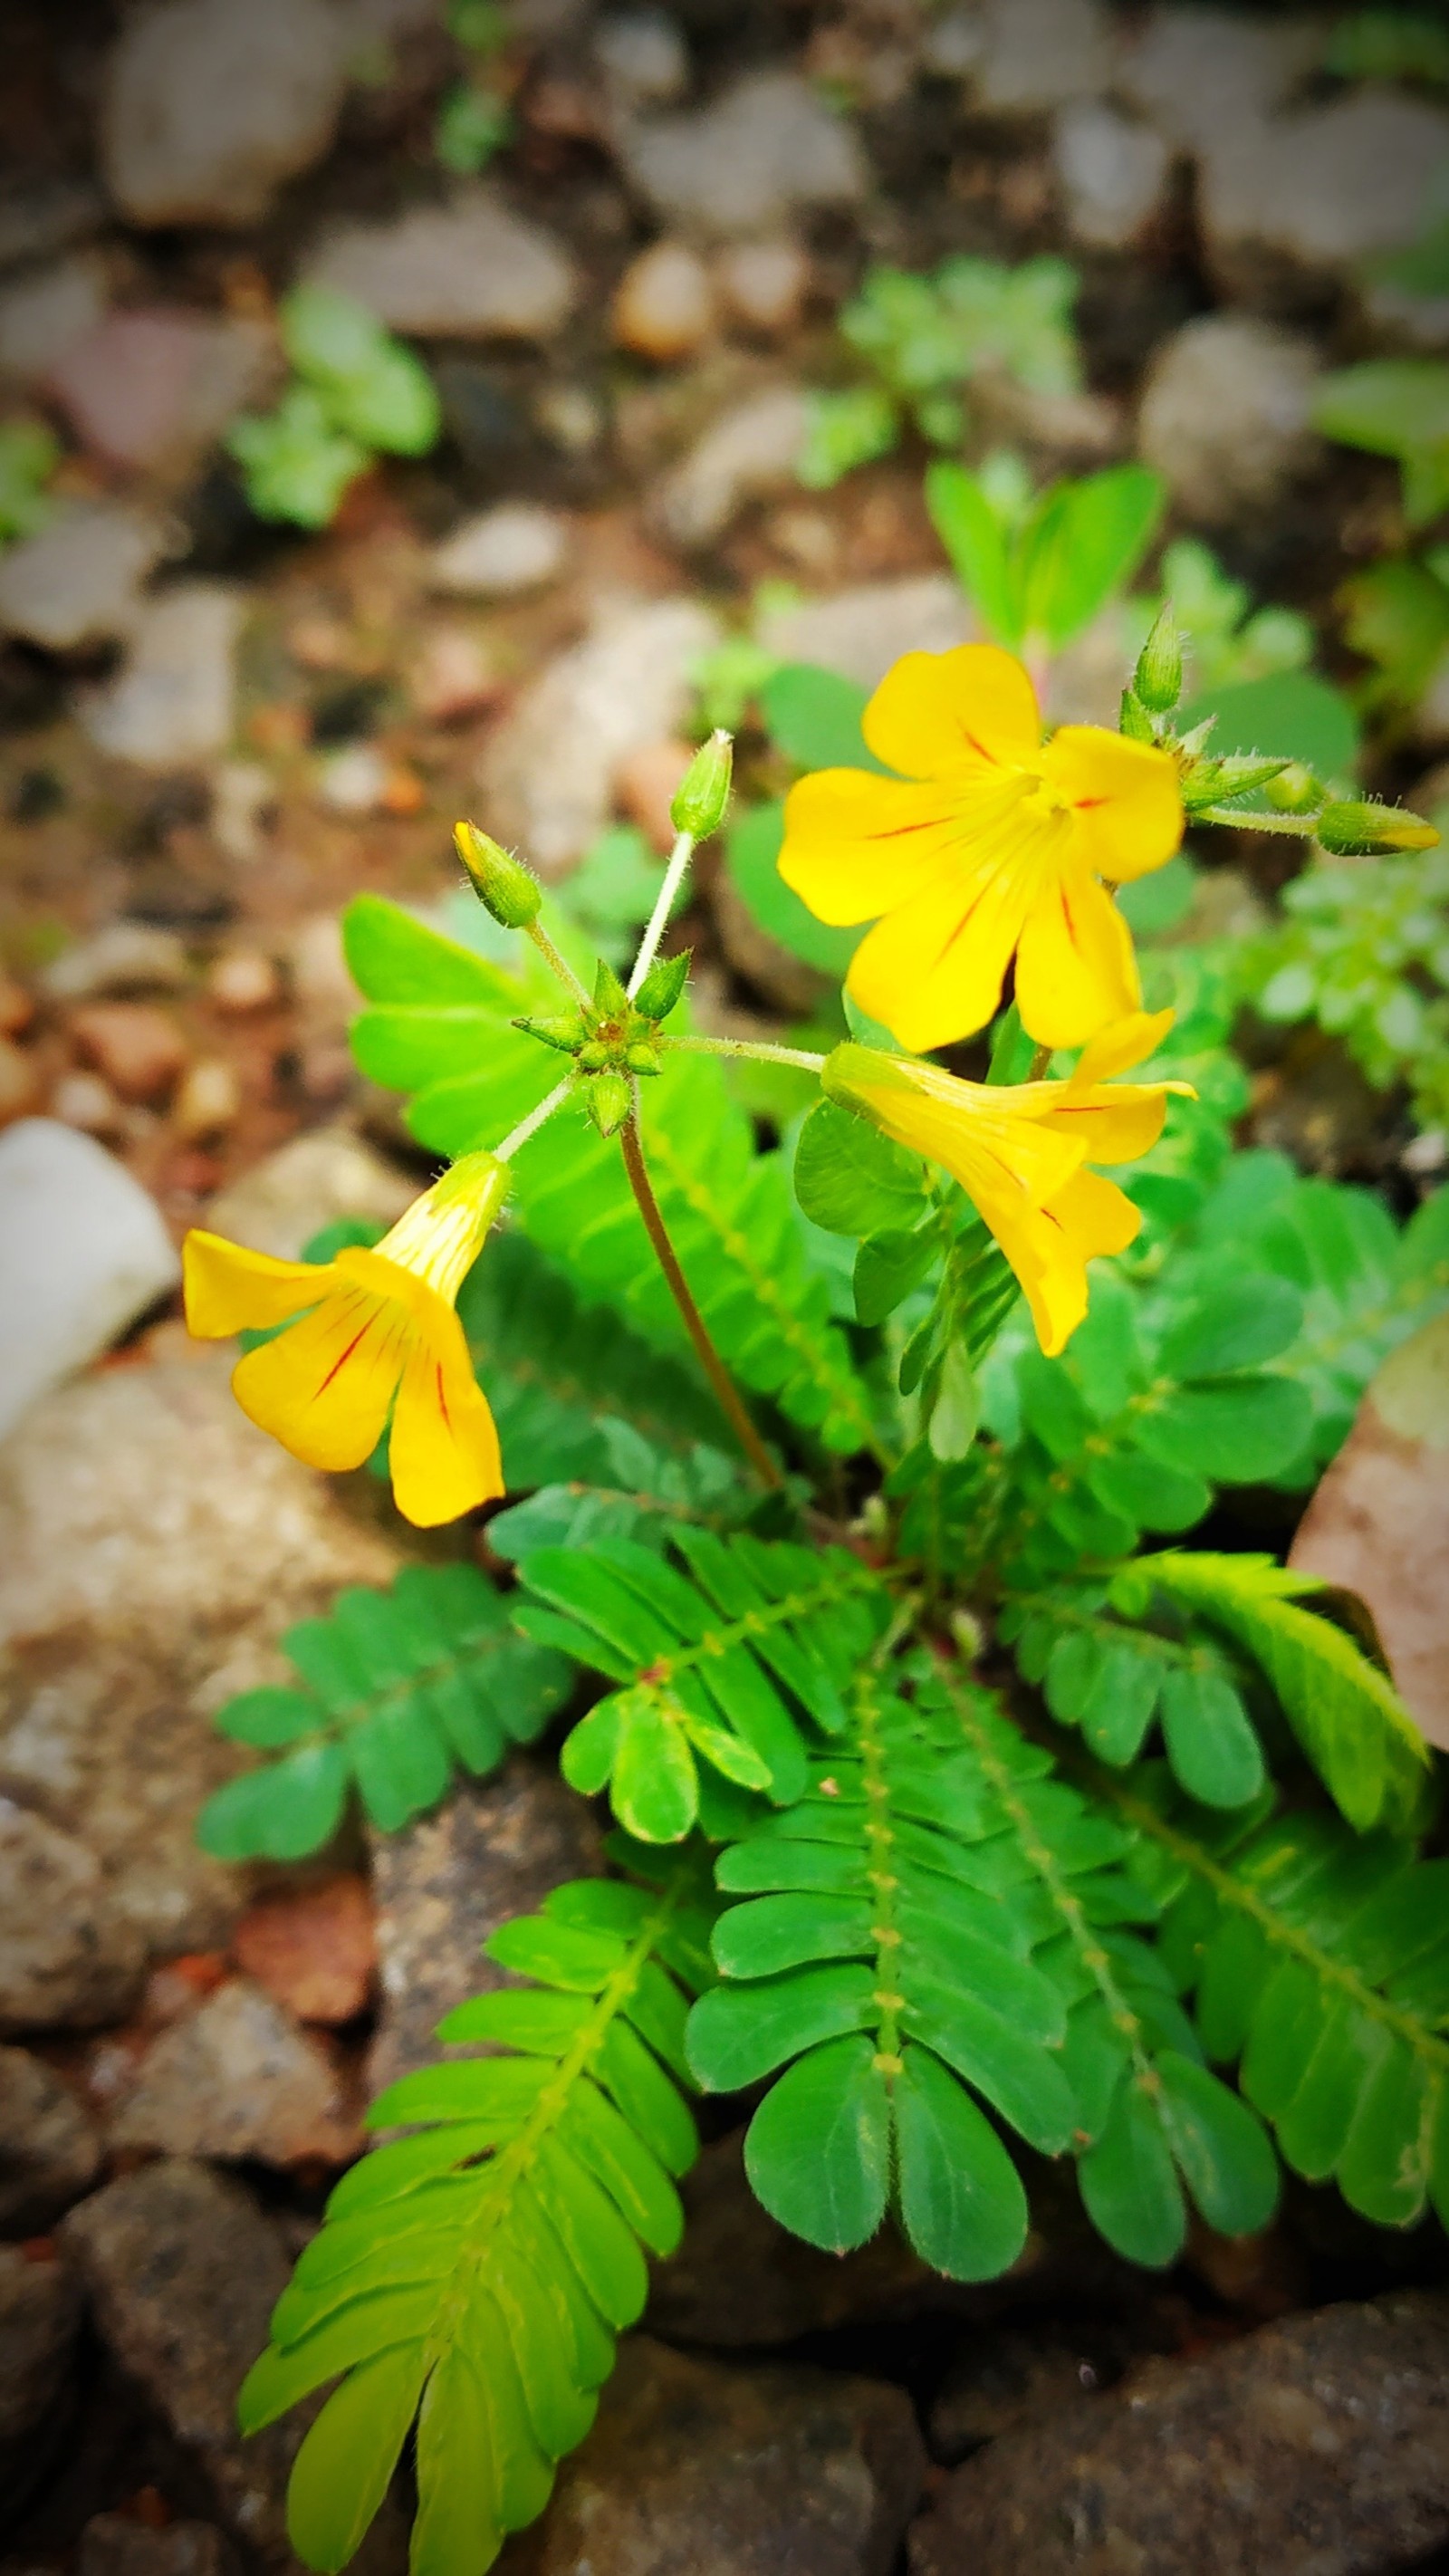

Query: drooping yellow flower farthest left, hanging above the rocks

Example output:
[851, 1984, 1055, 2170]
[183, 1154, 510, 1530]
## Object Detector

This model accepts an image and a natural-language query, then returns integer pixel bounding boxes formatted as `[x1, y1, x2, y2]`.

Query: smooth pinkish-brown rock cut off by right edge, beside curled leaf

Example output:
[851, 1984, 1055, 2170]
[1290, 1313, 1449, 1752]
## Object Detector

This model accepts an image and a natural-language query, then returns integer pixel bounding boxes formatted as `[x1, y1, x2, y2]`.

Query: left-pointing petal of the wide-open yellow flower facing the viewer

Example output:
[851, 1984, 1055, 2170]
[780, 770, 955, 925]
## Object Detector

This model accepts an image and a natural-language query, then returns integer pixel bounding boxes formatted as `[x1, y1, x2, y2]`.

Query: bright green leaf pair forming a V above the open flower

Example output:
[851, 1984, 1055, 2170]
[926, 464, 1164, 652]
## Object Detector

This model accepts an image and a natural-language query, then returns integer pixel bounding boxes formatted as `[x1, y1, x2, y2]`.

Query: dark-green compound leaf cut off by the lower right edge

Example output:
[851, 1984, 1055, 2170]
[1104, 1770, 1449, 2225]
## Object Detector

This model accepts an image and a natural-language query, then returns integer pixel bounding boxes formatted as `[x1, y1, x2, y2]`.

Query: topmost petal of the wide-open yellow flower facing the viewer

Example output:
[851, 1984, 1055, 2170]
[859, 644, 1042, 778]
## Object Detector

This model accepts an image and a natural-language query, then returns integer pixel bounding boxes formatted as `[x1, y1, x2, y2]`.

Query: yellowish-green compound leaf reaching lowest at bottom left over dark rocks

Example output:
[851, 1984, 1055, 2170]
[239, 1868, 710, 2576]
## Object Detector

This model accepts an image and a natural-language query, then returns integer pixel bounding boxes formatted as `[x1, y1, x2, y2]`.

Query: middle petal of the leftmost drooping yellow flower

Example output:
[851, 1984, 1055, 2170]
[232, 1283, 415, 1471]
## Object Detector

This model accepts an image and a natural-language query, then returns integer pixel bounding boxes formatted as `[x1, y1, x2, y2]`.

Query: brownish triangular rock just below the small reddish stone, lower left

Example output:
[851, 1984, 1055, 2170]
[108, 1975, 363, 2167]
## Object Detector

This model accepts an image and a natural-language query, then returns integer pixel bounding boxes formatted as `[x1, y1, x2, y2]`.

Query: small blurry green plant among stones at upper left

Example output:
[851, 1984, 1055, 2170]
[226, 286, 443, 528]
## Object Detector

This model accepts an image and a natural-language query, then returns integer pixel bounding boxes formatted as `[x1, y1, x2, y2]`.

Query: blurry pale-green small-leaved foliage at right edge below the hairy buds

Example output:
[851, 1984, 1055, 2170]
[1238, 845, 1449, 1126]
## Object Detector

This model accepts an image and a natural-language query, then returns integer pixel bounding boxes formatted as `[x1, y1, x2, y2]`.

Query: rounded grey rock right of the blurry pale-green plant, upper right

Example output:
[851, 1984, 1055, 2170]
[1137, 314, 1318, 528]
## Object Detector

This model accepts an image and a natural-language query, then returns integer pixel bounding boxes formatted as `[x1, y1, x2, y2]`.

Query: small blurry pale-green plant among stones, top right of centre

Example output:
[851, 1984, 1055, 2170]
[798, 257, 1081, 492]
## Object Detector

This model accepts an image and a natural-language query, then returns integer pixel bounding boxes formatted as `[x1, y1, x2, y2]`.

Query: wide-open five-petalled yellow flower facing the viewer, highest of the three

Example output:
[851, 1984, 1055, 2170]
[780, 644, 1181, 1053]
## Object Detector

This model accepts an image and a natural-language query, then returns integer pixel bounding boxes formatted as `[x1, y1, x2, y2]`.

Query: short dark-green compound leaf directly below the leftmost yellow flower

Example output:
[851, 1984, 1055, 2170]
[196, 1566, 571, 1860]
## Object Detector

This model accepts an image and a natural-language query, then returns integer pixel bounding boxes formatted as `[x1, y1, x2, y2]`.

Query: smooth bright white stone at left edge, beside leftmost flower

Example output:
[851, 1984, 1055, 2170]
[0, 1118, 180, 1435]
